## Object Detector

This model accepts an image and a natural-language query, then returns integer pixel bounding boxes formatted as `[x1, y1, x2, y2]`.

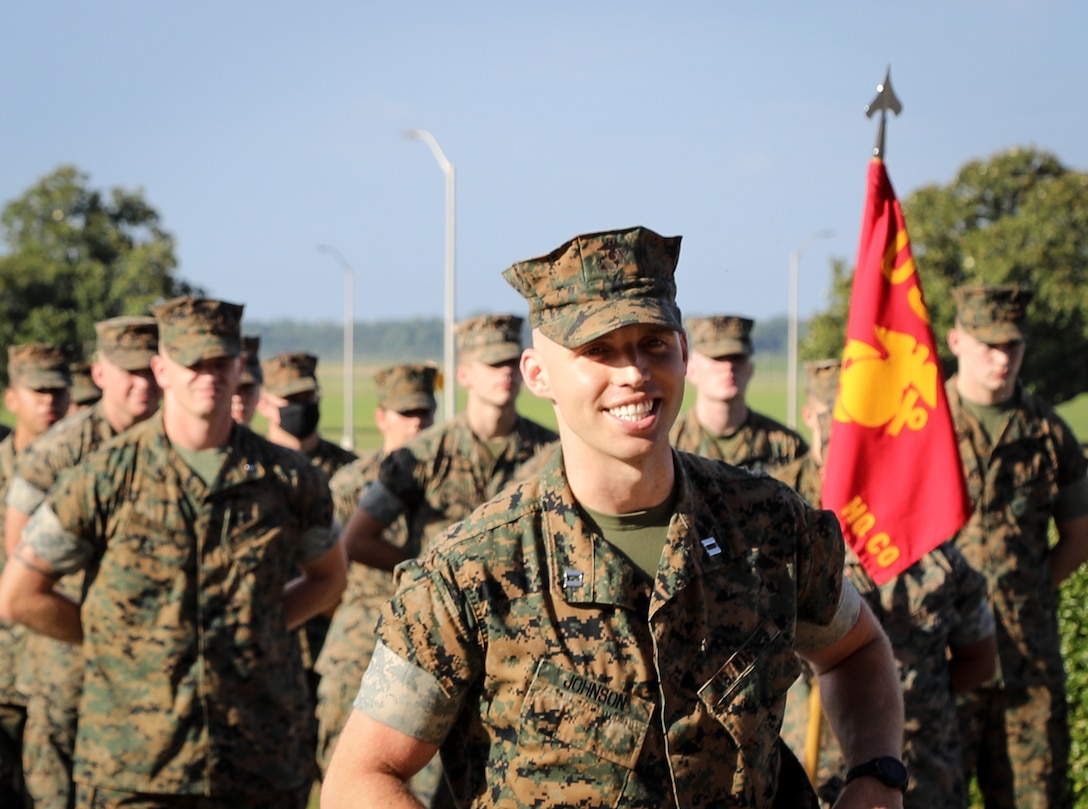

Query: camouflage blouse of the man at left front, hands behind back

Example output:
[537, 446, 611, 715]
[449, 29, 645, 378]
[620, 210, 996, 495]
[24, 414, 335, 795]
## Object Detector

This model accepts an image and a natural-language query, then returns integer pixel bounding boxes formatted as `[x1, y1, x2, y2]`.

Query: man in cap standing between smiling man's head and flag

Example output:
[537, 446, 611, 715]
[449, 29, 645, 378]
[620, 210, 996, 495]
[671, 315, 808, 471]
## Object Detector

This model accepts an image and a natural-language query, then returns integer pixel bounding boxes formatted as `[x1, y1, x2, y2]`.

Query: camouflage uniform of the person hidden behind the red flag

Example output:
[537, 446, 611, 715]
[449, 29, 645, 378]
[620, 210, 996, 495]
[776, 455, 994, 809]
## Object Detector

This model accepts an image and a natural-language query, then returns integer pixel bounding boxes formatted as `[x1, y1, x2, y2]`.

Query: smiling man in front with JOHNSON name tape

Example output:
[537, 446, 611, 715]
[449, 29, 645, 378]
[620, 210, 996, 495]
[322, 227, 903, 809]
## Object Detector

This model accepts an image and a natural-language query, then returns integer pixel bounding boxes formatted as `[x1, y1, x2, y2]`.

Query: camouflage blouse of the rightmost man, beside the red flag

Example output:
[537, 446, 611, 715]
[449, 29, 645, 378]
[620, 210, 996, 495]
[945, 376, 1088, 688]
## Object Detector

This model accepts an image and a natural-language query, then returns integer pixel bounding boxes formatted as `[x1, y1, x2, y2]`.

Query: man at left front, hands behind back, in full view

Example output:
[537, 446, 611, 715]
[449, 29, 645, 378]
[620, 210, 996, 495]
[0, 297, 345, 809]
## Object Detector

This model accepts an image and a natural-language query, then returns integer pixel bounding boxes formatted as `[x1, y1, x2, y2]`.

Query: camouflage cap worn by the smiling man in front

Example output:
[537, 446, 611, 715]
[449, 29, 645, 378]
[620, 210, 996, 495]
[503, 227, 683, 348]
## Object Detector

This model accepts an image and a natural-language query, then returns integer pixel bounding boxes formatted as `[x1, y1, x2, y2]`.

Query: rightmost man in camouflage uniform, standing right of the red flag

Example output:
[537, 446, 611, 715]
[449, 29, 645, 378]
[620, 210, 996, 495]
[945, 285, 1088, 809]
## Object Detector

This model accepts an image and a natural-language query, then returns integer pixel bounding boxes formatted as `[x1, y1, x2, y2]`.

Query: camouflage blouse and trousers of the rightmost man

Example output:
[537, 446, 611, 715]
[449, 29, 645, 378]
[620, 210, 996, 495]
[947, 376, 1086, 806]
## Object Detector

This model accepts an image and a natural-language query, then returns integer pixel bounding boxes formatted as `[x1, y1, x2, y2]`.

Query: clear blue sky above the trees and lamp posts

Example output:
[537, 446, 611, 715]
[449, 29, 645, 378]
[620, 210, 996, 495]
[0, 0, 1088, 321]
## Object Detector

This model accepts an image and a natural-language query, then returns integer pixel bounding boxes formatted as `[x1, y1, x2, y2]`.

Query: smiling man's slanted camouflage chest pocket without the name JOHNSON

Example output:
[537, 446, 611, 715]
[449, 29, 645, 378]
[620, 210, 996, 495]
[698, 620, 801, 747]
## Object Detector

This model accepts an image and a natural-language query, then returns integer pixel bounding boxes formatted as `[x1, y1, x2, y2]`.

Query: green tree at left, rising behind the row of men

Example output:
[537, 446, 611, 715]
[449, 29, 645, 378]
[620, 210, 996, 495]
[0, 165, 199, 384]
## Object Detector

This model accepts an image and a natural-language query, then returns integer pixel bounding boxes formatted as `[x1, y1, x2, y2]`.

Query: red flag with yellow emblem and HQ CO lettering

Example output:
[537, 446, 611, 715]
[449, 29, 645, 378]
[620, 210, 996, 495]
[821, 158, 970, 584]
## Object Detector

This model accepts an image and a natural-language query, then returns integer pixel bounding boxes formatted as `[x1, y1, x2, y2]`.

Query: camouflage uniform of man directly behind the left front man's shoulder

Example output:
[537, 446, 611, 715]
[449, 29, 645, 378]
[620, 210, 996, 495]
[9, 403, 115, 809]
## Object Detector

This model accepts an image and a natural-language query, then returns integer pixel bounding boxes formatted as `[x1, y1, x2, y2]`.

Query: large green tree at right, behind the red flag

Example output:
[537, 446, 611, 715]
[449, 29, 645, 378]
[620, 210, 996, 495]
[802, 149, 1088, 403]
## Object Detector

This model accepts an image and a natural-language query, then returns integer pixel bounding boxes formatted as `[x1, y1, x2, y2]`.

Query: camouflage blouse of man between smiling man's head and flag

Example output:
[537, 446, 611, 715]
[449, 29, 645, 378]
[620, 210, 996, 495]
[669, 408, 808, 473]
